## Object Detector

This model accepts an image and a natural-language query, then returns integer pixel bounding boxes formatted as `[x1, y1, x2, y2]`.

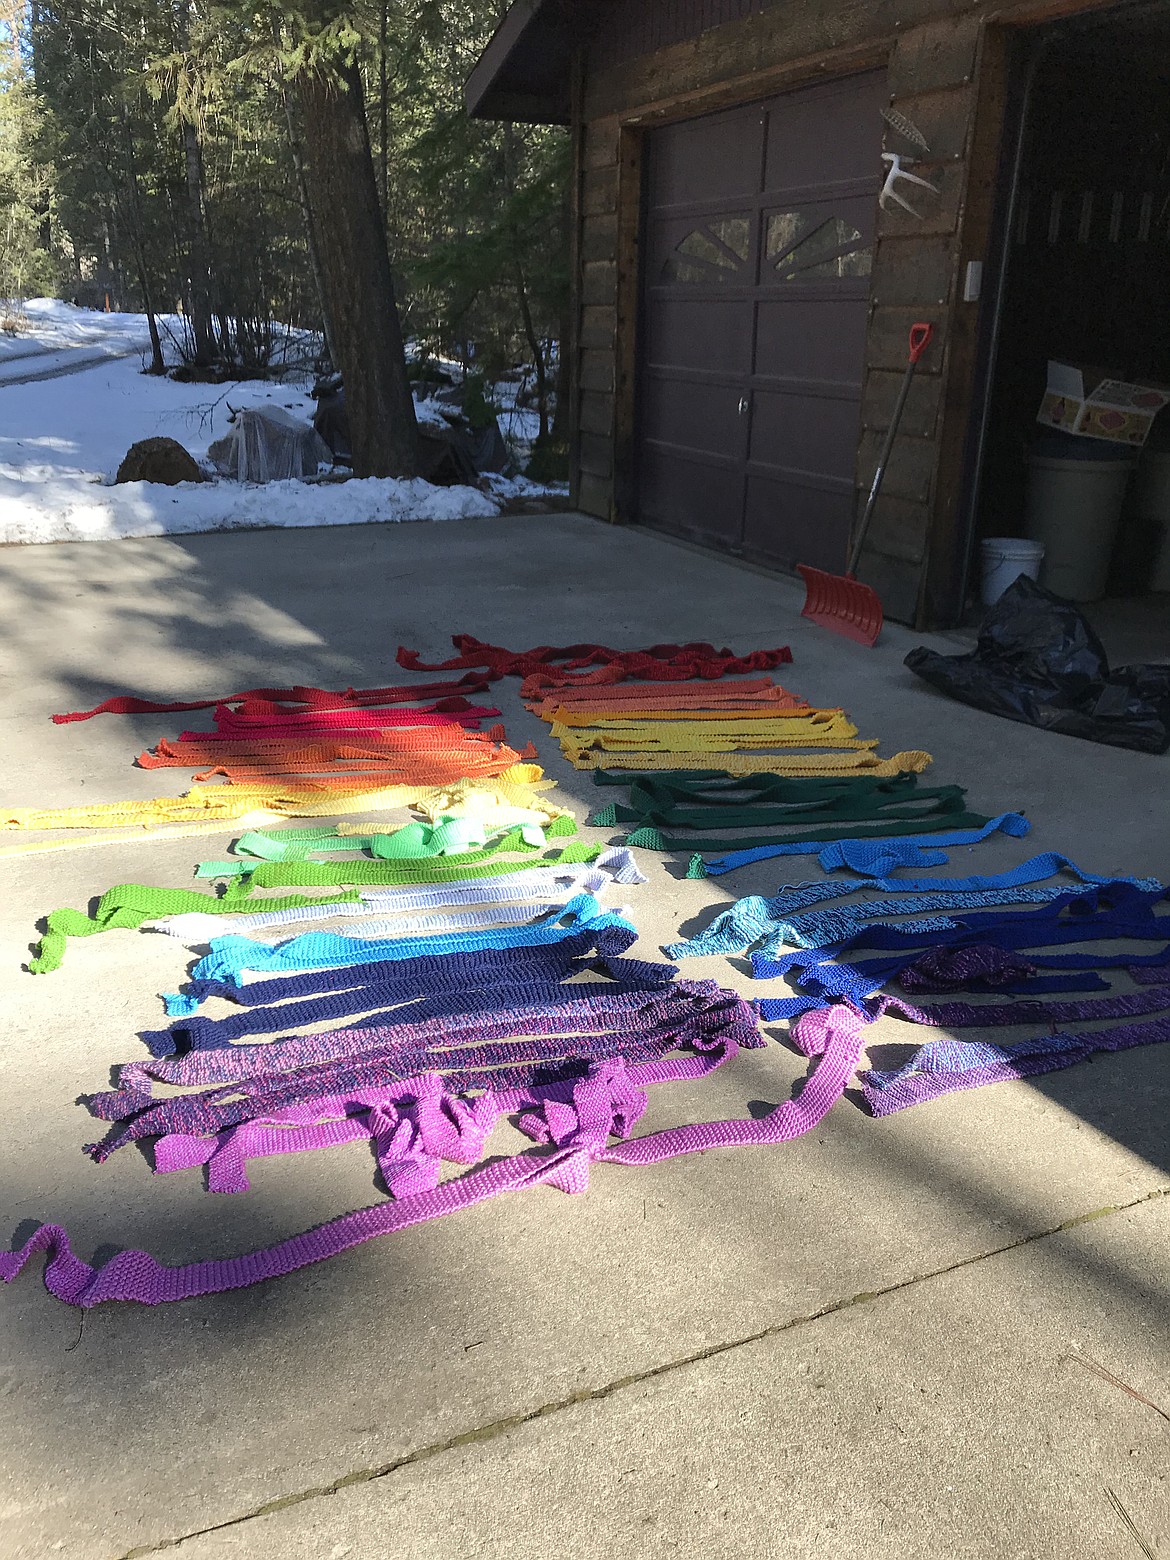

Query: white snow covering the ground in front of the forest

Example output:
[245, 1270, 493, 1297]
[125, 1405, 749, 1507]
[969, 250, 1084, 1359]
[0, 298, 549, 543]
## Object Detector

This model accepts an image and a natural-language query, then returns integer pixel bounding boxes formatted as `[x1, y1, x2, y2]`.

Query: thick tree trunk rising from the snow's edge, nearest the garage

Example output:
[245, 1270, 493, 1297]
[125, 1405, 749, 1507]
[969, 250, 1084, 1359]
[296, 61, 418, 477]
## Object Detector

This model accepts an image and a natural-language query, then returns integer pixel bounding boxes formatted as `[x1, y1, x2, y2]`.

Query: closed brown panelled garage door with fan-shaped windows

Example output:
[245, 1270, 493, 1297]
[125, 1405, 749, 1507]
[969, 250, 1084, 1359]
[638, 72, 888, 569]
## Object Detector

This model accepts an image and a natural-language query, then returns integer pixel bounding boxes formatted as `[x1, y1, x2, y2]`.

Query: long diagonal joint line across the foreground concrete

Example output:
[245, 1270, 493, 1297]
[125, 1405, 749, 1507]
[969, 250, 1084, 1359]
[117, 1182, 1170, 1560]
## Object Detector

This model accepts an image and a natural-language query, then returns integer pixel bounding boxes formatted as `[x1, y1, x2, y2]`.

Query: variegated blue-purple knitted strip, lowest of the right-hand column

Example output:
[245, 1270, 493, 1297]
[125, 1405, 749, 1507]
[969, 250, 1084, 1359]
[861, 1019, 1170, 1115]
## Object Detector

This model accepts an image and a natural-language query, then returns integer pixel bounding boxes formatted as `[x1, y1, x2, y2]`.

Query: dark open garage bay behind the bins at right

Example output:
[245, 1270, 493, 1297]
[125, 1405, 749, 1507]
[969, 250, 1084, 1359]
[975, 3, 1170, 660]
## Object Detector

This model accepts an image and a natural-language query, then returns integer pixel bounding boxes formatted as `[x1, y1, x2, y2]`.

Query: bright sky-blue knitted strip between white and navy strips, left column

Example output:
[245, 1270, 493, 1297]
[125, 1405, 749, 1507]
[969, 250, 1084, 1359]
[192, 894, 635, 984]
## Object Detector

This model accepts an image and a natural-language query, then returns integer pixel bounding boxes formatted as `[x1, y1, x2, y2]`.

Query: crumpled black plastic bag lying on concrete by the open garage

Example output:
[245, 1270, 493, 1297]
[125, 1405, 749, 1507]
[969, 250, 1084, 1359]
[906, 574, 1170, 753]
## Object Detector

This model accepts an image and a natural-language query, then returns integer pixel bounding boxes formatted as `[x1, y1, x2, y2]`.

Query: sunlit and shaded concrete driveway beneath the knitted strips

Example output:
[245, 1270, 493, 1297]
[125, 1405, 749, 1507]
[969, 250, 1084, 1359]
[0, 515, 1170, 1560]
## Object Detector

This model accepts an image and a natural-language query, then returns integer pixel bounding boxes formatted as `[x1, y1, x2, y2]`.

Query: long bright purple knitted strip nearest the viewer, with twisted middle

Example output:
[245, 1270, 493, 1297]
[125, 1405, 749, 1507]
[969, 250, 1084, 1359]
[0, 1008, 863, 1307]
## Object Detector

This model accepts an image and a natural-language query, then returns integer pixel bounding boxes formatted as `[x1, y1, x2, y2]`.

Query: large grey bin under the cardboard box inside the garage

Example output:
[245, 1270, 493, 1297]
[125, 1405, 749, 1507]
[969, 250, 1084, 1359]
[1025, 456, 1134, 601]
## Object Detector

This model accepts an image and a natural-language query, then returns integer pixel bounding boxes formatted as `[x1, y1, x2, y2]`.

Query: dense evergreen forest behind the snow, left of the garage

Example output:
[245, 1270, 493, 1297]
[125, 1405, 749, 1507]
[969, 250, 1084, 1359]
[0, 0, 568, 476]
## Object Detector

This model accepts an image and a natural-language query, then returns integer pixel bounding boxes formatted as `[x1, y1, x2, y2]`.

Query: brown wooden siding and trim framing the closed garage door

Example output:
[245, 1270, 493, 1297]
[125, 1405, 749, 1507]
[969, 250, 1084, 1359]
[576, 0, 1135, 626]
